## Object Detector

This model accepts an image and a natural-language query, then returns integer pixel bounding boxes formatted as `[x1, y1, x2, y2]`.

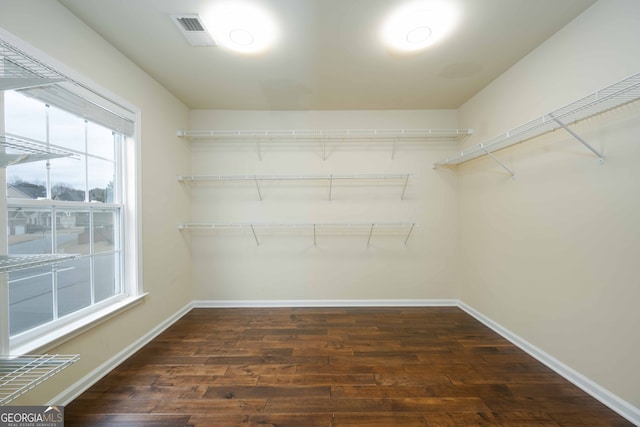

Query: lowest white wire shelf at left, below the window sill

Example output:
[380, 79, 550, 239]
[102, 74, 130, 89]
[0, 354, 80, 405]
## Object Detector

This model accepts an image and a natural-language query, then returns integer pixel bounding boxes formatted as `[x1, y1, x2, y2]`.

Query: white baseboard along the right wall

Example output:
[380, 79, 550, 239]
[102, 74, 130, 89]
[458, 301, 640, 426]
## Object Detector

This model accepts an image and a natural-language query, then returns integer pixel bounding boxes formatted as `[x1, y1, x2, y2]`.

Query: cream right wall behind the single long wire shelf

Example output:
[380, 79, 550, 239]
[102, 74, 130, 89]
[459, 0, 640, 407]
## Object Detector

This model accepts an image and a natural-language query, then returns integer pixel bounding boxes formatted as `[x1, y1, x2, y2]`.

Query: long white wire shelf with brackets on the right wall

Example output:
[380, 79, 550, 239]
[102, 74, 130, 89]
[434, 73, 640, 175]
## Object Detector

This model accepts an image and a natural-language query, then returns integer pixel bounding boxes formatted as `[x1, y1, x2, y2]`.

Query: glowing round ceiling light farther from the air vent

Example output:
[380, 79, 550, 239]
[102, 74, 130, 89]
[382, 0, 458, 51]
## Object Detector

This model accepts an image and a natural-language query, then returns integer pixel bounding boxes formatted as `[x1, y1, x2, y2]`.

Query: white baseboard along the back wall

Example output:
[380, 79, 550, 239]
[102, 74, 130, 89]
[193, 299, 458, 308]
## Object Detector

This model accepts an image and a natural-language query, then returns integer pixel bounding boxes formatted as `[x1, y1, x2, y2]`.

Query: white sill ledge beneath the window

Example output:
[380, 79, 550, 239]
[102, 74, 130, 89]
[11, 293, 148, 355]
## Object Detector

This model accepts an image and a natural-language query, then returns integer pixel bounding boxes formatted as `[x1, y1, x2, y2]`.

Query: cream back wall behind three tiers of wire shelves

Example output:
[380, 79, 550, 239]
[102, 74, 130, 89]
[184, 111, 458, 302]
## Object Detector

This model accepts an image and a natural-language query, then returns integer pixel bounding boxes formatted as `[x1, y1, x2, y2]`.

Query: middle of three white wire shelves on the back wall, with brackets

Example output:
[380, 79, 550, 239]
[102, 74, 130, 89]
[178, 174, 412, 201]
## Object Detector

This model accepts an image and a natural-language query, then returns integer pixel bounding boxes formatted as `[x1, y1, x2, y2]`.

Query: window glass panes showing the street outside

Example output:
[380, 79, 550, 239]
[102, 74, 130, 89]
[4, 92, 126, 337]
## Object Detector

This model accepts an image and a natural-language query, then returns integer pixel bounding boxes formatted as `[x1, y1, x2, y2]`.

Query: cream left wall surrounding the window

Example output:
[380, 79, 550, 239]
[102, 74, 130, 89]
[0, 0, 191, 404]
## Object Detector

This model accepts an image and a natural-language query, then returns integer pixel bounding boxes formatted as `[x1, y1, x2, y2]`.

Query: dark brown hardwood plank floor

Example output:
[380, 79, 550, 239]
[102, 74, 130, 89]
[65, 307, 631, 427]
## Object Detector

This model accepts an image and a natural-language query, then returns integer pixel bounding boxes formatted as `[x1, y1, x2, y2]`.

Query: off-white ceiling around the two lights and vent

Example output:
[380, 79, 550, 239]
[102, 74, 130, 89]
[58, 0, 595, 110]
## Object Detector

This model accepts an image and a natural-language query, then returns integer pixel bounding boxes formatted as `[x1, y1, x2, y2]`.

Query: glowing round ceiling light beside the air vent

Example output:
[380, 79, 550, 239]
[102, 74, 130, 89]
[202, 2, 276, 54]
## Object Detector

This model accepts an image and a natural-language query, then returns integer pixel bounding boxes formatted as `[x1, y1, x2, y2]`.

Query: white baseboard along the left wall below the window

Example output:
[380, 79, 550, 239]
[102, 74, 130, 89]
[47, 303, 193, 405]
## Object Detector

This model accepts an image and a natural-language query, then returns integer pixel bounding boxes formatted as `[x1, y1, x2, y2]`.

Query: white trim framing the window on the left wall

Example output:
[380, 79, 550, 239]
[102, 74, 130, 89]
[0, 28, 147, 355]
